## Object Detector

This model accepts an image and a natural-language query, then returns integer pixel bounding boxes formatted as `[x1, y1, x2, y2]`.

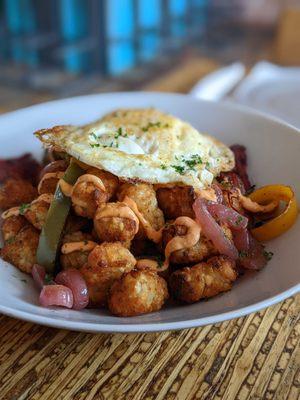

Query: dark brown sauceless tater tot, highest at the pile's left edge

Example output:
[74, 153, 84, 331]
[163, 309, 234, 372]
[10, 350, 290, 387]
[0, 179, 37, 210]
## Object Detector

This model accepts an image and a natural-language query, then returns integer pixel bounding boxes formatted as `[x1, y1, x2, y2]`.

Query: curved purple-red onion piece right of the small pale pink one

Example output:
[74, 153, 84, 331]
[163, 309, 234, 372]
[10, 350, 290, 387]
[55, 269, 89, 310]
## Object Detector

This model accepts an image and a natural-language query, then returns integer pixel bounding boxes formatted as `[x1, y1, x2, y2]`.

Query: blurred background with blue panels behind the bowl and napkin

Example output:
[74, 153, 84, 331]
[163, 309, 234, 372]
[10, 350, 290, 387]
[0, 0, 300, 111]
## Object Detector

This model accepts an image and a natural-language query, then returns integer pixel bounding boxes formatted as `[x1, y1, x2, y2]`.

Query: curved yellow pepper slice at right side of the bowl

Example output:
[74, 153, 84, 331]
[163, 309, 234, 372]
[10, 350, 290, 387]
[249, 185, 298, 242]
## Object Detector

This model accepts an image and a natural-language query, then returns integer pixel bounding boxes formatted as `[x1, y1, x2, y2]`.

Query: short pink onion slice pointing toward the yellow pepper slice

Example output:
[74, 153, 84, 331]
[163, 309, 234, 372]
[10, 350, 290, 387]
[207, 202, 248, 230]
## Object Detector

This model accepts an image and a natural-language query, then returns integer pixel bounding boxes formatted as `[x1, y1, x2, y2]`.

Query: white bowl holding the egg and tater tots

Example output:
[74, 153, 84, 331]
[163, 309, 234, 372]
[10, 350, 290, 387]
[0, 92, 300, 332]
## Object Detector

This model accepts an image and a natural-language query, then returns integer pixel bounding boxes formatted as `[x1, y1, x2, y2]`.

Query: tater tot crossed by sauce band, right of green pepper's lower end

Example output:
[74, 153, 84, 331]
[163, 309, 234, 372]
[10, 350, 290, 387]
[60, 231, 93, 269]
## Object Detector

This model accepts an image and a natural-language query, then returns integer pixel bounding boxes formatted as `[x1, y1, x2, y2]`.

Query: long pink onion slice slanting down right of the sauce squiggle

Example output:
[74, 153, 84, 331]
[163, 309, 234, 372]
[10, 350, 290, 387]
[193, 197, 238, 260]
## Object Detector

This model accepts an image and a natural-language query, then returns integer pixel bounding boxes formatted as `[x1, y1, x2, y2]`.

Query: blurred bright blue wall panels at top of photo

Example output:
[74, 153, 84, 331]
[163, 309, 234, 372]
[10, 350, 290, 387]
[0, 0, 208, 75]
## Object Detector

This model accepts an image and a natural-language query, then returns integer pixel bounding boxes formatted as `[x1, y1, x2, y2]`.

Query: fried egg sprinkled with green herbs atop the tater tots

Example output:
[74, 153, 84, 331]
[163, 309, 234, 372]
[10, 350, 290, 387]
[35, 108, 234, 188]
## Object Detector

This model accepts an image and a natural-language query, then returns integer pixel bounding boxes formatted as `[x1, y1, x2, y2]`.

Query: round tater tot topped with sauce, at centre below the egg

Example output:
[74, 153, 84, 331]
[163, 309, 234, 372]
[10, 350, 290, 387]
[94, 202, 139, 247]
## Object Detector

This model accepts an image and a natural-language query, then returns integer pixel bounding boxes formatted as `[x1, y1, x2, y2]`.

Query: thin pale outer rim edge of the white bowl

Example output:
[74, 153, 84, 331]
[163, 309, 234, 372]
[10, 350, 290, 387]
[0, 91, 300, 333]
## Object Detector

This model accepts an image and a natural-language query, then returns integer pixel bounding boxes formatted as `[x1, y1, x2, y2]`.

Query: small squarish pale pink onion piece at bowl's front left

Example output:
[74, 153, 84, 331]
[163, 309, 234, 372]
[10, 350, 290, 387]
[40, 285, 73, 308]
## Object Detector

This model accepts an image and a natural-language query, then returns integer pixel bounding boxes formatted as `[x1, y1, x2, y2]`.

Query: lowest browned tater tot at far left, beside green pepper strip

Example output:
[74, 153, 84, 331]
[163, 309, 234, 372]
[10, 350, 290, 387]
[1, 225, 39, 273]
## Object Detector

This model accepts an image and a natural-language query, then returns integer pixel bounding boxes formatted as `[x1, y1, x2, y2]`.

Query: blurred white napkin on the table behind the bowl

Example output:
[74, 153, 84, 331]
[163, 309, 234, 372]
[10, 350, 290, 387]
[191, 61, 300, 128]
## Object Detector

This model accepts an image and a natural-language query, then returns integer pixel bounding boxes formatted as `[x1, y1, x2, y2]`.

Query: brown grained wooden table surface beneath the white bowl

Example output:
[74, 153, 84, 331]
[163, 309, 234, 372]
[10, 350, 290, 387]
[0, 59, 300, 400]
